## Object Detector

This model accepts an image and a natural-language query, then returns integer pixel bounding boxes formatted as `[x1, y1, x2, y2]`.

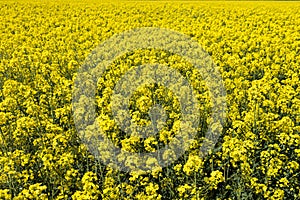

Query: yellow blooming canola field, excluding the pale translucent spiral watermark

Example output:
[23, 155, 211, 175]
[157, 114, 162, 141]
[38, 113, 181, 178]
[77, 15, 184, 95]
[0, 0, 300, 200]
